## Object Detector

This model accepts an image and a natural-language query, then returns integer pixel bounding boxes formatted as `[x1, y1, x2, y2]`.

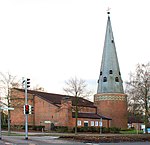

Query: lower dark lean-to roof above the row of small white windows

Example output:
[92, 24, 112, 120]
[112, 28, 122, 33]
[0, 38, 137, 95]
[72, 112, 112, 120]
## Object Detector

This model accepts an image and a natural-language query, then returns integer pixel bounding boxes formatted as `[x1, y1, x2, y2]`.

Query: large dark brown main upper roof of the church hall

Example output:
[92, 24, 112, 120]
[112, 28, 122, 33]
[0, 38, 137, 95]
[14, 88, 96, 108]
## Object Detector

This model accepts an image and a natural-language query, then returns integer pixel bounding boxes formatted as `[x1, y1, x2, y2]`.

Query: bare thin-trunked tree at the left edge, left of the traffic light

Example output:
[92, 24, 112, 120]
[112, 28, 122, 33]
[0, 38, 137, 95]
[0, 72, 21, 134]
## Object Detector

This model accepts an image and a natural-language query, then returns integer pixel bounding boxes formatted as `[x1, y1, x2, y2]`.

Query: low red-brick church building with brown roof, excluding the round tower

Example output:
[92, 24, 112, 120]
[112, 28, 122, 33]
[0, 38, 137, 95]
[11, 88, 111, 130]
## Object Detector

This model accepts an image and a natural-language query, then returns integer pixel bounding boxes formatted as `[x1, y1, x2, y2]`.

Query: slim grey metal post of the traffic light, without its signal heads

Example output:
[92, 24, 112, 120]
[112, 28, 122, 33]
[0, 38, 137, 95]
[25, 79, 28, 140]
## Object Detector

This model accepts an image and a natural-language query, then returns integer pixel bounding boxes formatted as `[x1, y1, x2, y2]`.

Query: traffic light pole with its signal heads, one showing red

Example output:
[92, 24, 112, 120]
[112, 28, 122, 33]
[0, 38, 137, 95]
[22, 78, 30, 140]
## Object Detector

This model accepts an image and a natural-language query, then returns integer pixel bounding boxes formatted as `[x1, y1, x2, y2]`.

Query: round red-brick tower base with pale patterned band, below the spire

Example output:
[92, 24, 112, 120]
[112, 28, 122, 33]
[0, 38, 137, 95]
[94, 93, 127, 128]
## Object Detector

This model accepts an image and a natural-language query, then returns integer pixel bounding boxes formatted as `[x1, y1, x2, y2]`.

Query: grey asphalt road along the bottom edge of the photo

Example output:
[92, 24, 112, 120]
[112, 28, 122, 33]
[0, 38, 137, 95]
[0, 136, 150, 145]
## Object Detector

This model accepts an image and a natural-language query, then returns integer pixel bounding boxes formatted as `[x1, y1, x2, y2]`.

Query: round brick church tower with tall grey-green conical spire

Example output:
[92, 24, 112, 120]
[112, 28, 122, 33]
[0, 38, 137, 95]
[94, 12, 127, 128]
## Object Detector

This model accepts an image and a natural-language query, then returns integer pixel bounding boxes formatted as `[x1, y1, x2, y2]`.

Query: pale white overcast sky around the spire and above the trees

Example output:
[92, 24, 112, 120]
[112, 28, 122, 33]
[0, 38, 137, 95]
[0, 0, 150, 98]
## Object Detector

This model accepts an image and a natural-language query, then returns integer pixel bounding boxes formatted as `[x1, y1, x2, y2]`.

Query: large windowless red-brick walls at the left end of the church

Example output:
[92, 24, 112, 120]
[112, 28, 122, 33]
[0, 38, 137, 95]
[11, 89, 79, 129]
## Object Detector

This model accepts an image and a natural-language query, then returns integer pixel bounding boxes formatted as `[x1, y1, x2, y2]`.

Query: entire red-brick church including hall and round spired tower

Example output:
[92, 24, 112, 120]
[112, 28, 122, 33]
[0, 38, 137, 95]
[11, 14, 127, 130]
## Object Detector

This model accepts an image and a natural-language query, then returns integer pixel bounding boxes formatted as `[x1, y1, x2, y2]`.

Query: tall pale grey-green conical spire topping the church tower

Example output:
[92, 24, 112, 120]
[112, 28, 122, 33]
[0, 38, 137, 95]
[97, 12, 124, 94]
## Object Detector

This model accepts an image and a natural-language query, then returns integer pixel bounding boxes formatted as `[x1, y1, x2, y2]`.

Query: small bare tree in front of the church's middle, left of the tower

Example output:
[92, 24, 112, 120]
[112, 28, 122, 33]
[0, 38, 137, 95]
[64, 77, 90, 135]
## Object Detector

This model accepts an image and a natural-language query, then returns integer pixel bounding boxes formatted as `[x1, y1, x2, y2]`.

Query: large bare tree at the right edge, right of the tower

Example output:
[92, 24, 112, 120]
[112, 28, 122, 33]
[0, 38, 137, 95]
[126, 62, 150, 133]
